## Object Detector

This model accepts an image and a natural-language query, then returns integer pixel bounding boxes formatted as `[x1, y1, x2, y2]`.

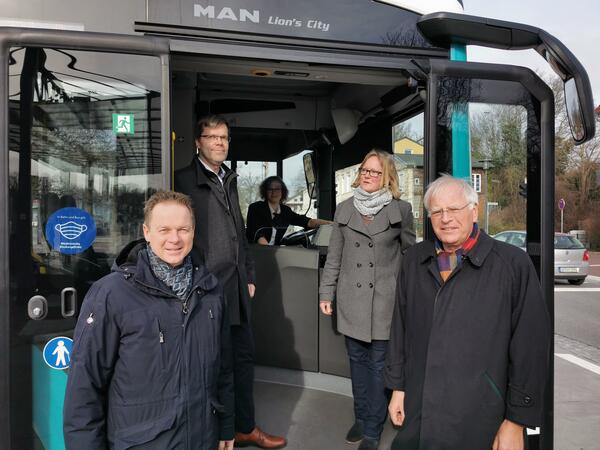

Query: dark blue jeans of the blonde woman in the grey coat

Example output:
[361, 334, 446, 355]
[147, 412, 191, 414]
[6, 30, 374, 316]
[346, 336, 388, 440]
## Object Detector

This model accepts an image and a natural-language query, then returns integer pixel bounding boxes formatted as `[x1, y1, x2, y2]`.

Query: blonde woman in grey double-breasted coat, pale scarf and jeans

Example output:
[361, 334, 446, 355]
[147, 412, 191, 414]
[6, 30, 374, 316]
[319, 150, 415, 450]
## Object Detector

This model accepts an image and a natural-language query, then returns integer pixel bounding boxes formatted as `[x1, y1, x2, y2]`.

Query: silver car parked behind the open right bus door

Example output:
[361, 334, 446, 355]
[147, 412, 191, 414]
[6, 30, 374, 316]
[493, 230, 590, 285]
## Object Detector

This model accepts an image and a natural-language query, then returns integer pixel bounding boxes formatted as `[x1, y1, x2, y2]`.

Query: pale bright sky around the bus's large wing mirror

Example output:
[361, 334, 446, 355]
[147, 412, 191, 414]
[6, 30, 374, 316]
[463, 0, 600, 106]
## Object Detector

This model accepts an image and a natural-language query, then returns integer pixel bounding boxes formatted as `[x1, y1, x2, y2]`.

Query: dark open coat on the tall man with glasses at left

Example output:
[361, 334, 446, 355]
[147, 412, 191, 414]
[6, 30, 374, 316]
[175, 156, 254, 325]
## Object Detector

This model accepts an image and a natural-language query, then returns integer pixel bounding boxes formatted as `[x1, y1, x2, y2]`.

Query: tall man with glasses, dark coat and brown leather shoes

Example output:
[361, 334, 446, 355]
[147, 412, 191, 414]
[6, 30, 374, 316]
[175, 115, 286, 448]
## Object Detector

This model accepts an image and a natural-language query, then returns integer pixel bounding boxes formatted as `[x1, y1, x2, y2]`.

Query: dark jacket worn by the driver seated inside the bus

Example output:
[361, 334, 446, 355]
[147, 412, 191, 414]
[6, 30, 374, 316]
[246, 201, 310, 245]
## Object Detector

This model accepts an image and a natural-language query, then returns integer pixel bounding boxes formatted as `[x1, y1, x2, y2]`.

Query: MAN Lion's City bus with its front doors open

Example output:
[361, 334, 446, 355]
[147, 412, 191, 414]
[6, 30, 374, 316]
[0, 0, 595, 450]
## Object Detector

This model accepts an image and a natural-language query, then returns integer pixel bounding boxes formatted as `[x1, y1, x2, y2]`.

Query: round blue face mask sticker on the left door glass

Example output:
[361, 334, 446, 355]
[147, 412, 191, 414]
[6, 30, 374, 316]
[46, 208, 96, 255]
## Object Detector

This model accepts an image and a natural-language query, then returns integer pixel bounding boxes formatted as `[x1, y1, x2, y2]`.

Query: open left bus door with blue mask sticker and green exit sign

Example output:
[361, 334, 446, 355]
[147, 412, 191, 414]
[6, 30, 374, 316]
[0, 28, 170, 450]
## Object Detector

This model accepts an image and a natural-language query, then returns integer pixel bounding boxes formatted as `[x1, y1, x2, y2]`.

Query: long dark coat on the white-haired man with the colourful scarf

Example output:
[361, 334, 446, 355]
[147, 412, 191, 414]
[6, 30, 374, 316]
[385, 232, 551, 450]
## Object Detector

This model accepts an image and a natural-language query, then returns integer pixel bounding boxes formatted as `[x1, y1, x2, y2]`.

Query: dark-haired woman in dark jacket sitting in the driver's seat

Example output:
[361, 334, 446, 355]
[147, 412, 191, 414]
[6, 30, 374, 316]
[246, 176, 331, 245]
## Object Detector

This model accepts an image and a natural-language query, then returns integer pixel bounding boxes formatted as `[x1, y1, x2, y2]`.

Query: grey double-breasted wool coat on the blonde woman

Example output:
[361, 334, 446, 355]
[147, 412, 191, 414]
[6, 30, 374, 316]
[319, 197, 415, 342]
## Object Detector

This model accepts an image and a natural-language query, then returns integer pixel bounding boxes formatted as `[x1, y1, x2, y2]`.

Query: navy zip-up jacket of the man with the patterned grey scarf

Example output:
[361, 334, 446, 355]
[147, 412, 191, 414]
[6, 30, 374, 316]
[64, 241, 234, 450]
